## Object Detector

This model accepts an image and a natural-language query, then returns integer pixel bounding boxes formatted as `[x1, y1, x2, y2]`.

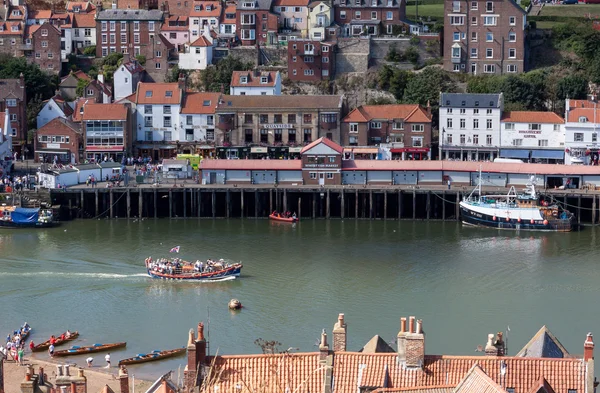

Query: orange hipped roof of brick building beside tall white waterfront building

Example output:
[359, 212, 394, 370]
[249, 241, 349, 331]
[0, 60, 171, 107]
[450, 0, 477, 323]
[342, 104, 431, 123]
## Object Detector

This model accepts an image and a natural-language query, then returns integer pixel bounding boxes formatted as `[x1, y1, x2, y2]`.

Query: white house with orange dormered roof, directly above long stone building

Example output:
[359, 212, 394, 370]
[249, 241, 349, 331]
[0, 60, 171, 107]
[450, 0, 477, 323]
[229, 70, 281, 96]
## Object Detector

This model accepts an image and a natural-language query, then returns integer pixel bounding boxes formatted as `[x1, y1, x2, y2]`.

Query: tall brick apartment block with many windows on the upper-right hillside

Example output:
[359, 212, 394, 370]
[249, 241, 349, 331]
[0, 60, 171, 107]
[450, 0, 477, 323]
[444, 0, 527, 75]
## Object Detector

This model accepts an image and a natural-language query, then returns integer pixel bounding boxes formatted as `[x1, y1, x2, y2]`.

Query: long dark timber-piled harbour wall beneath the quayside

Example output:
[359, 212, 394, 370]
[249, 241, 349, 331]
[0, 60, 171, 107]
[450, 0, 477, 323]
[50, 185, 600, 225]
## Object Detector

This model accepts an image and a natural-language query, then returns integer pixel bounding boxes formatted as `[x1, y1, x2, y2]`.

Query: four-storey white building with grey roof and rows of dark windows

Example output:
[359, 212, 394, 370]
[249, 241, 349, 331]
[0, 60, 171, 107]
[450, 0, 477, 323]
[439, 93, 504, 161]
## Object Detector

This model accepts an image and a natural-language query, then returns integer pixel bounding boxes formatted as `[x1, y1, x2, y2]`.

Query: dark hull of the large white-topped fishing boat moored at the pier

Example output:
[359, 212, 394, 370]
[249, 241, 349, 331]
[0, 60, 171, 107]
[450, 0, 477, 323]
[460, 202, 573, 232]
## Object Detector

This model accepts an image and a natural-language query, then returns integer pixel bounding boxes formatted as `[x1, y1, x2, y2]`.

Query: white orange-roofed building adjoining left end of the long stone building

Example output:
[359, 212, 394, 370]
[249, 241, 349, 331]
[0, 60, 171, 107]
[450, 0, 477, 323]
[179, 93, 221, 142]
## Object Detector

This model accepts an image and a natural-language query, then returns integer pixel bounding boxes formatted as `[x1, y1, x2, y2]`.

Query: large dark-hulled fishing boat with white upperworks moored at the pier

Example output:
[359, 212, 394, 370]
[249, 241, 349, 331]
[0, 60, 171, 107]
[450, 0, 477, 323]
[460, 171, 575, 232]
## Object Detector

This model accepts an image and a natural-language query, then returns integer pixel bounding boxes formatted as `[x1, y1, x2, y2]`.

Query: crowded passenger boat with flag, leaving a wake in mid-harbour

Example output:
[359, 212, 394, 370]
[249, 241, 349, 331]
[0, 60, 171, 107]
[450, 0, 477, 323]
[145, 257, 242, 281]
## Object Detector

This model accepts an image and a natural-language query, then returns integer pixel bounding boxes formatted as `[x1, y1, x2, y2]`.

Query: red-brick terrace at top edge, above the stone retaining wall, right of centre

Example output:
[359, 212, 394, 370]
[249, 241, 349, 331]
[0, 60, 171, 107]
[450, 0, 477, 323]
[333, 0, 407, 37]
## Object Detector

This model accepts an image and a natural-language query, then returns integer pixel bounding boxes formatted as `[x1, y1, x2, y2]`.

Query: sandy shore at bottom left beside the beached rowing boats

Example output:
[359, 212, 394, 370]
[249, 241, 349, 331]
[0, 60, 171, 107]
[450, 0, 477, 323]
[4, 353, 154, 393]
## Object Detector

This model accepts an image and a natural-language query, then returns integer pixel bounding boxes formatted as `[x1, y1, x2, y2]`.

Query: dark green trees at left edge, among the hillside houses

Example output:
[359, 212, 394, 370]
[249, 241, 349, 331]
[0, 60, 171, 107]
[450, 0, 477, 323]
[0, 55, 59, 101]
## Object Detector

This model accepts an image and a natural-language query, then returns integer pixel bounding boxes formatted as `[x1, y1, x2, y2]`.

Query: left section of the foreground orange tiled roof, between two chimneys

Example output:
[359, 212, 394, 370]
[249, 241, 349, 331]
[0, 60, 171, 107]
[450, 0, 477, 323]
[207, 352, 328, 393]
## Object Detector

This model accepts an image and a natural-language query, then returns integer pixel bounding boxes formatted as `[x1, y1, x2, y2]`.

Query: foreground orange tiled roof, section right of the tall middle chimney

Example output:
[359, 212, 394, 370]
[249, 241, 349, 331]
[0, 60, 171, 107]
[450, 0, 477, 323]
[333, 352, 586, 393]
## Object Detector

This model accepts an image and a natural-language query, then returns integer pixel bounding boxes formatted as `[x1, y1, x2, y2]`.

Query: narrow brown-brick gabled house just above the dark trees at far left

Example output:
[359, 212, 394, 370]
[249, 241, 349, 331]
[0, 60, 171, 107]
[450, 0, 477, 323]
[29, 22, 62, 74]
